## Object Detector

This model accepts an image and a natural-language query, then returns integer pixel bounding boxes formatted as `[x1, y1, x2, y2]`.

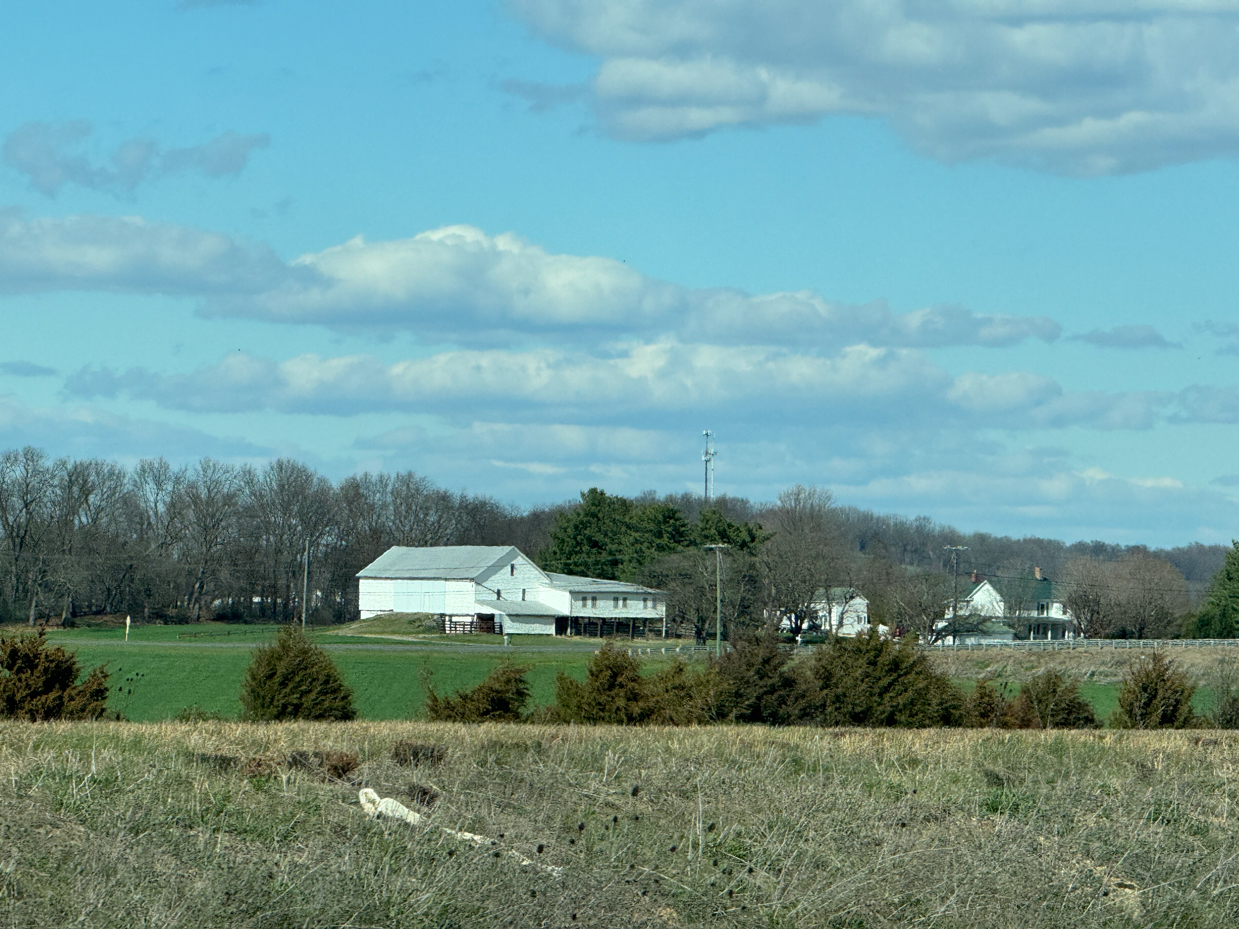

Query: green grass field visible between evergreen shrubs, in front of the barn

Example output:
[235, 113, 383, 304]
[5, 629, 1239, 722]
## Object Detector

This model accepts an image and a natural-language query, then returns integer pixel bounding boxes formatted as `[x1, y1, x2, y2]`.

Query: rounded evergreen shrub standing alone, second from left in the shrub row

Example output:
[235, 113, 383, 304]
[240, 626, 357, 722]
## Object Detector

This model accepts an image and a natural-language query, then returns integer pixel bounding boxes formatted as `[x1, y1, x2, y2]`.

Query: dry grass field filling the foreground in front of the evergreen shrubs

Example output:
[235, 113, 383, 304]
[0, 722, 1239, 929]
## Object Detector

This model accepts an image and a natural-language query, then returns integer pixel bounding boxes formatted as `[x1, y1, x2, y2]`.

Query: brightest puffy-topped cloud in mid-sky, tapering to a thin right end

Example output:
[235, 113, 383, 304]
[207, 225, 1061, 348]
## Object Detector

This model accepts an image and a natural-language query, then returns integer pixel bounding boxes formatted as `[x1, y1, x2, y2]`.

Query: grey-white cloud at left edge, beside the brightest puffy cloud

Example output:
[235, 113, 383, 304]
[0, 209, 292, 296]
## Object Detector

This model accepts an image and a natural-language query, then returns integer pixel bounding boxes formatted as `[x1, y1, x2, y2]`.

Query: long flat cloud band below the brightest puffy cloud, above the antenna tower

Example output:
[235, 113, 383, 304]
[66, 342, 949, 420]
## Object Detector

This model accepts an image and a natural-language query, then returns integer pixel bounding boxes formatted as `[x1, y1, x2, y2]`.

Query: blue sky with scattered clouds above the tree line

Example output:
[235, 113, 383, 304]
[0, 0, 1239, 545]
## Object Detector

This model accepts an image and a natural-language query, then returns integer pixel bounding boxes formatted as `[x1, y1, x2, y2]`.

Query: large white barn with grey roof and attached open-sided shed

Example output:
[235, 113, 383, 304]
[357, 545, 667, 637]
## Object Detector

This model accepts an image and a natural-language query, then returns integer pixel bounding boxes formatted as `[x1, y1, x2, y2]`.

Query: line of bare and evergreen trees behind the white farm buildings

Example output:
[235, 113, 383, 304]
[0, 447, 1239, 638]
